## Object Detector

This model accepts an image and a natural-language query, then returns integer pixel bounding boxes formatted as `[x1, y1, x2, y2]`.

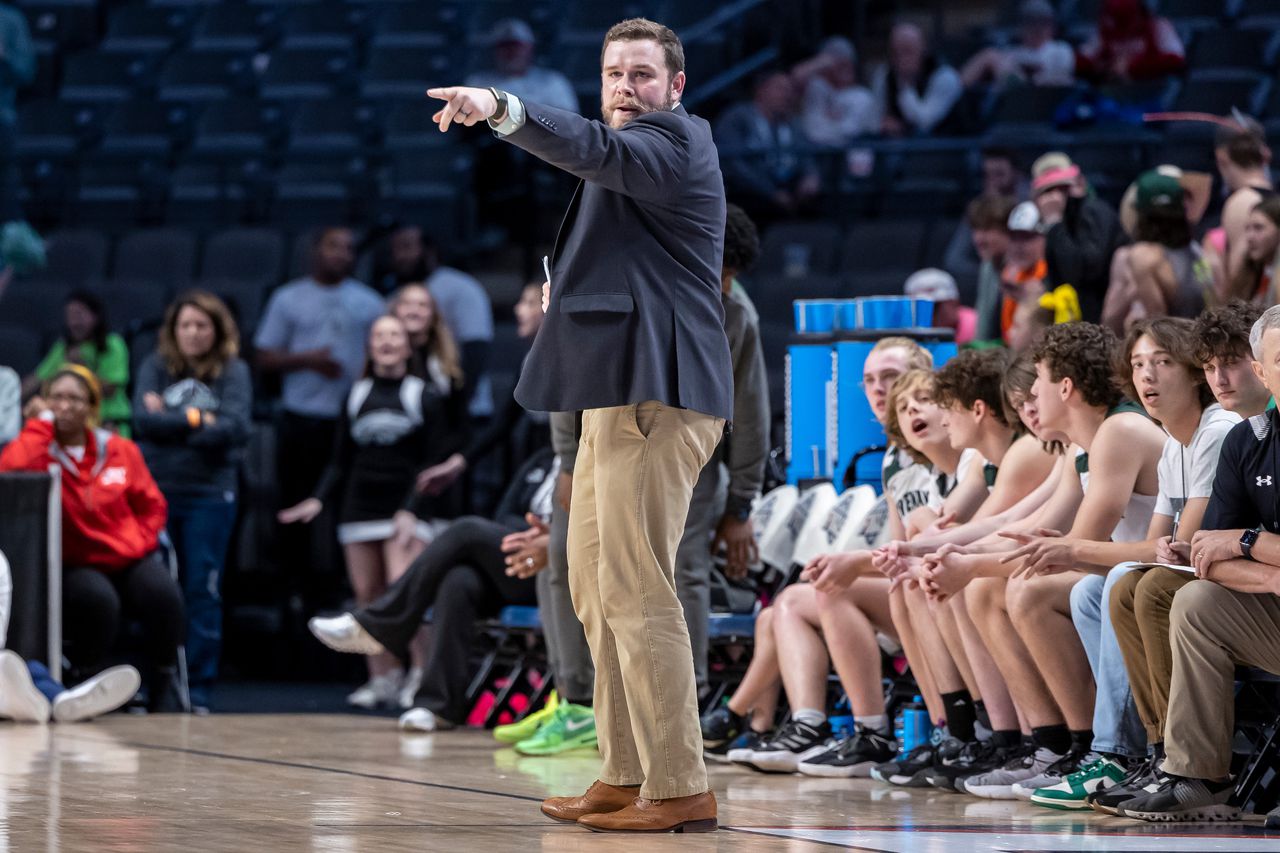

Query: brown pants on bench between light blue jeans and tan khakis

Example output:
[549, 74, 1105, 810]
[1108, 569, 1196, 743]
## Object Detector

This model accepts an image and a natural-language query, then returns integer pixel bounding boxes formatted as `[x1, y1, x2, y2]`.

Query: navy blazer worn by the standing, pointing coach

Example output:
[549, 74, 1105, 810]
[506, 101, 733, 420]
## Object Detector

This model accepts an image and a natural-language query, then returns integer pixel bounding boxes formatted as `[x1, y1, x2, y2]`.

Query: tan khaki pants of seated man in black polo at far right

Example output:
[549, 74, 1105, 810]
[1164, 580, 1280, 779]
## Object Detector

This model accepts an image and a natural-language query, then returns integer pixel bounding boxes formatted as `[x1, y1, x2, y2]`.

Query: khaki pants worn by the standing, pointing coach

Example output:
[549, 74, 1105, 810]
[568, 401, 724, 799]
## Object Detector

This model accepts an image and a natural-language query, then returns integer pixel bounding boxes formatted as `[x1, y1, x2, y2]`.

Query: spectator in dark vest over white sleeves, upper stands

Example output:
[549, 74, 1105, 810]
[872, 23, 964, 136]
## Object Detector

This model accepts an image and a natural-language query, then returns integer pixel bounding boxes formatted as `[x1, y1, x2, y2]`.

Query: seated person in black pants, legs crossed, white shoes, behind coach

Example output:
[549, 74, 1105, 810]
[310, 448, 558, 731]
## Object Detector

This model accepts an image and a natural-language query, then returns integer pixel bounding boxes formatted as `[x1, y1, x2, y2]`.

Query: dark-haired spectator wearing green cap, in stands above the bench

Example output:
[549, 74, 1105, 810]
[1102, 167, 1213, 334]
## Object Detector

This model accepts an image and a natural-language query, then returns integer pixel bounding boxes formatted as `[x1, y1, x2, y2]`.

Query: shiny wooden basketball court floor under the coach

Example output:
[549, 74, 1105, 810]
[0, 715, 1280, 853]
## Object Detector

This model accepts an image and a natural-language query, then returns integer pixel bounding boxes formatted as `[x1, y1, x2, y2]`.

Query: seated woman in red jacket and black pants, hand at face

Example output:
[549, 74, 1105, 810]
[0, 365, 184, 711]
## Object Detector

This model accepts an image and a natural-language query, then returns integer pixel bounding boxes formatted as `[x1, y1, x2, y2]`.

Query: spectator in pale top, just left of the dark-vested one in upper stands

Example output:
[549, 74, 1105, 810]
[791, 36, 879, 149]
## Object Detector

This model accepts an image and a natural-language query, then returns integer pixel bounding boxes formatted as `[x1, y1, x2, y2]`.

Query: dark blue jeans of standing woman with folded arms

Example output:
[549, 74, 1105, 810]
[169, 494, 236, 707]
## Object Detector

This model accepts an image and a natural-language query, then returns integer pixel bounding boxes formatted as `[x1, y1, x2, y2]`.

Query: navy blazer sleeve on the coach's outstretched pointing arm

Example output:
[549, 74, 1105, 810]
[500, 101, 694, 202]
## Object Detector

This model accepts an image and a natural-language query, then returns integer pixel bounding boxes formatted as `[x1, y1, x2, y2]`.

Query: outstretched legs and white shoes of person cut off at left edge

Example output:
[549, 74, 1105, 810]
[0, 553, 142, 722]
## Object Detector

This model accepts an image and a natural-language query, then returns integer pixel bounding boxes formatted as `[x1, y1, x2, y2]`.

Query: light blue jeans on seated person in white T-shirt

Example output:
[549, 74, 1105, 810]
[1071, 562, 1147, 758]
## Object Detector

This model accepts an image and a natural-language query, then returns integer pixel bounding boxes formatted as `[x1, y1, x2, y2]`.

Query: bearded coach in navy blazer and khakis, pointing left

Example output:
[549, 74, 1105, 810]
[428, 19, 733, 833]
